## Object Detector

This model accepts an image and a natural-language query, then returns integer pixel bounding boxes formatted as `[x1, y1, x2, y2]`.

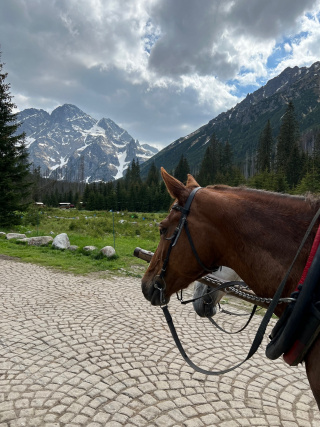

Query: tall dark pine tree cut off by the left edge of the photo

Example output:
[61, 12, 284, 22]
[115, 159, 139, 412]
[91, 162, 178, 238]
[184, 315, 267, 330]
[0, 53, 31, 226]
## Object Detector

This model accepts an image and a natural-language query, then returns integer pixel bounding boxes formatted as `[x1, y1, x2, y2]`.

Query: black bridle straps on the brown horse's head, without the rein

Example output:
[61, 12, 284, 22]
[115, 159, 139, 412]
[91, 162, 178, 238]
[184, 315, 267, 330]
[154, 187, 219, 305]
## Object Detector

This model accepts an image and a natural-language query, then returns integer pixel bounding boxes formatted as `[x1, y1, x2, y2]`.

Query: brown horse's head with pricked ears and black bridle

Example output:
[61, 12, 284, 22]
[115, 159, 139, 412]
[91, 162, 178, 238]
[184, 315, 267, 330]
[142, 168, 224, 305]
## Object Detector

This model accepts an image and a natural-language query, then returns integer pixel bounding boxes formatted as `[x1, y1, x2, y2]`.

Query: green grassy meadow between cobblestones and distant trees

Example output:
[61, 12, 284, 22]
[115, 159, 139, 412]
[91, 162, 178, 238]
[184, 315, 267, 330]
[0, 209, 166, 277]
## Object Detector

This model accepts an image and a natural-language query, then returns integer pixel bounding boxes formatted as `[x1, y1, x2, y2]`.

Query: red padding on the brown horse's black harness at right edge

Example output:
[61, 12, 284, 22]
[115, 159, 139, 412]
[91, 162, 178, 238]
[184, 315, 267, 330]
[283, 225, 320, 366]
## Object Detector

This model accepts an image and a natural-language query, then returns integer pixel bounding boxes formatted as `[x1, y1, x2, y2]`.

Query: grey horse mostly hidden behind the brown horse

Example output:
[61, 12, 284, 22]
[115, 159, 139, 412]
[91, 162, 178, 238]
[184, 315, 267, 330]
[192, 266, 241, 317]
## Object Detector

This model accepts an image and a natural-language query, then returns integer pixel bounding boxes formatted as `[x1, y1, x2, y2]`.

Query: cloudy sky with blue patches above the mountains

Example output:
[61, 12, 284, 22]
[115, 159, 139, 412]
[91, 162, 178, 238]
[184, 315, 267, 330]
[0, 0, 320, 149]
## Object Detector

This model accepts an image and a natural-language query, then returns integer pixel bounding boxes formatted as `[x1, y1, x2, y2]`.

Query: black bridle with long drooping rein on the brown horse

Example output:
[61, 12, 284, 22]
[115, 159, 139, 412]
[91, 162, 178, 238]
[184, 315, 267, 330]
[158, 187, 320, 375]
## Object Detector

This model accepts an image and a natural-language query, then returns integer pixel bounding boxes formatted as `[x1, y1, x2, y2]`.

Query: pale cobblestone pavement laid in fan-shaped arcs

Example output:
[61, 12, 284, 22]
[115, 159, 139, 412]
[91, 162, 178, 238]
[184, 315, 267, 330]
[0, 260, 320, 427]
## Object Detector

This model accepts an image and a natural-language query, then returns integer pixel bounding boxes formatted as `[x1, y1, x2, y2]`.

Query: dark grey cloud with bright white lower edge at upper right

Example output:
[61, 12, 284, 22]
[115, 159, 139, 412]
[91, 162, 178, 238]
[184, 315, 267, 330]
[149, 0, 315, 81]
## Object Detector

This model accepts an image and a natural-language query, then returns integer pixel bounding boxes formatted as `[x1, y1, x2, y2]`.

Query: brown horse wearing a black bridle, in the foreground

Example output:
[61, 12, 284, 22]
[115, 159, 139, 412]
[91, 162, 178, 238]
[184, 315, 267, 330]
[142, 168, 320, 408]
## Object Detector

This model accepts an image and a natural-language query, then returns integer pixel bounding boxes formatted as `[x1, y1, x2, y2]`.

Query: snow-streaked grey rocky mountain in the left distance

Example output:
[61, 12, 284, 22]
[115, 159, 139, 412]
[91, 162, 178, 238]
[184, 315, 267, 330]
[18, 104, 158, 182]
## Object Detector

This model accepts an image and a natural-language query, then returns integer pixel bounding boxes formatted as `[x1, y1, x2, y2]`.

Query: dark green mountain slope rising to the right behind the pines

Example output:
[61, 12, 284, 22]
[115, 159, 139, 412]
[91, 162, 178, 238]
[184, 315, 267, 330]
[141, 62, 320, 176]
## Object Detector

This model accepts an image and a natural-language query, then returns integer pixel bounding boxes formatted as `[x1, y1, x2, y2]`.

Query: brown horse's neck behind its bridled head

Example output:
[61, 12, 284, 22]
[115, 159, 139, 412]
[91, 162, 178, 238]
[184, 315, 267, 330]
[206, 190, 316, 297]
